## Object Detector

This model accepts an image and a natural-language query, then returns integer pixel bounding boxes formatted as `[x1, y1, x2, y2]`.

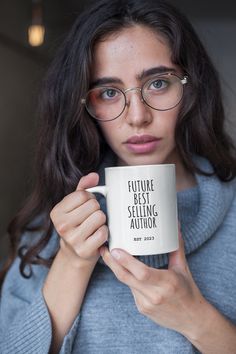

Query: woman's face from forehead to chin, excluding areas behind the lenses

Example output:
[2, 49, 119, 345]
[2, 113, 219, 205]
[92, 25, 182, 165]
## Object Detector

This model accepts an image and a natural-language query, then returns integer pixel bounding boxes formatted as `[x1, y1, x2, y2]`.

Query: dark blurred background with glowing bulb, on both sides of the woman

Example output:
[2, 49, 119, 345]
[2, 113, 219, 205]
[0, 0, 236, 262]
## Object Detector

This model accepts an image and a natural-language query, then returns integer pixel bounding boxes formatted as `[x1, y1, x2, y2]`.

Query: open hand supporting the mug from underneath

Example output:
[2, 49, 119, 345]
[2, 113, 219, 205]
[100, 236, 208, 336]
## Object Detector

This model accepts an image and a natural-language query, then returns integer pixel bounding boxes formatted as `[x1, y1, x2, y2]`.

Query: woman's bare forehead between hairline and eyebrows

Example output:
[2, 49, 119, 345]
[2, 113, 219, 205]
[92, 25, 177, 80]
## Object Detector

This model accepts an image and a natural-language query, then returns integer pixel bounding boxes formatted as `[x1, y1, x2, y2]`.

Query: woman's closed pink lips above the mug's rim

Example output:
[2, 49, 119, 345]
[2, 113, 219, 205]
[125, 135, 161, 154]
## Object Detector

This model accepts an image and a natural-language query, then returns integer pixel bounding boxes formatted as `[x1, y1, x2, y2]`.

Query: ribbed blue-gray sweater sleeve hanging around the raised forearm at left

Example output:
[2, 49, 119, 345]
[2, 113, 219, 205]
[0, 252, 79, 354]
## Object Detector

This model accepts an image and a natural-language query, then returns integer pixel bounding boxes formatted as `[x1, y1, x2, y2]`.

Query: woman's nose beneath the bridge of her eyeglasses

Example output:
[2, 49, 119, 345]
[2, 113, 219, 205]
[125, 87, 152, 126]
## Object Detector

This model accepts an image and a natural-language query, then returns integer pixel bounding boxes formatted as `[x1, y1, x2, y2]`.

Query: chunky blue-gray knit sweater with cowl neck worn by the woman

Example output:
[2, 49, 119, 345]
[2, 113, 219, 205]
[0, 158, 236, 354]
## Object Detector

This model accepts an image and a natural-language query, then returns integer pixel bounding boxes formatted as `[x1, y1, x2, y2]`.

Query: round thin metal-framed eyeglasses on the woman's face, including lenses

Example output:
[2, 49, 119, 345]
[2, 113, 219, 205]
[81, 73, 188, 121]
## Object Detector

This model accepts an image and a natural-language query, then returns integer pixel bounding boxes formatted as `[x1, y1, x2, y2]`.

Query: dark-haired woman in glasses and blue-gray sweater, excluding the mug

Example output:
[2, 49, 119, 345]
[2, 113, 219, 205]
[1, 0, 236, 354]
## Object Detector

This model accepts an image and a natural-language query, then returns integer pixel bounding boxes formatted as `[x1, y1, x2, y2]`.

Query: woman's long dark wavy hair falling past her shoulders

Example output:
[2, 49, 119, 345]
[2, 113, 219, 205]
[1, 0, 236, 280]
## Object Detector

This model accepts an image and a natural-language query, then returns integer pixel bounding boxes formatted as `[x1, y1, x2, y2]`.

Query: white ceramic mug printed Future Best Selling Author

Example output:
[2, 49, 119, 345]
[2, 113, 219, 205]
[87, 164, 179, 255]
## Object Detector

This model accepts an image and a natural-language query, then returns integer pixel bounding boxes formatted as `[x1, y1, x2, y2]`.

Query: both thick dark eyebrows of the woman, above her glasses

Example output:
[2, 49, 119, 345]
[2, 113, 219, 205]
[90, 65, 176, 88]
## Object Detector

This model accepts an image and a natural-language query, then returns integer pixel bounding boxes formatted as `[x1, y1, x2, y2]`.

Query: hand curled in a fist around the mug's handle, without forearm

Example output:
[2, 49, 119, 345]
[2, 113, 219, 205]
[50, 173, 108, 266]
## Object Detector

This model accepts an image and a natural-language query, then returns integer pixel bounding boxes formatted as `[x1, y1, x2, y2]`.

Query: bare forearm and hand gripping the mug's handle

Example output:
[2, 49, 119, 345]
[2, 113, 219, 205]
[43, 173, 108, 353]
